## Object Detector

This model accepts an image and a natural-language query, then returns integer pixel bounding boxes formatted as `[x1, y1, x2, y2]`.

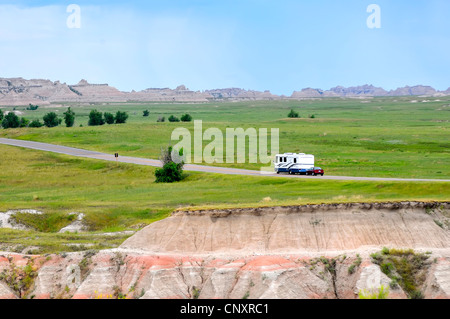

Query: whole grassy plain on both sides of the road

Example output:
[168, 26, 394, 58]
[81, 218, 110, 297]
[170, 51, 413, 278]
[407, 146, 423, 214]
[0, 97, 450, 253]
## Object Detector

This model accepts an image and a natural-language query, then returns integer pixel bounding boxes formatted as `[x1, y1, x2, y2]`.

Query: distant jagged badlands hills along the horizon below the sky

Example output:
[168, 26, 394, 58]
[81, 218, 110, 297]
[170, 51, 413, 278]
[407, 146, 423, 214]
[0, 78, 450, 106]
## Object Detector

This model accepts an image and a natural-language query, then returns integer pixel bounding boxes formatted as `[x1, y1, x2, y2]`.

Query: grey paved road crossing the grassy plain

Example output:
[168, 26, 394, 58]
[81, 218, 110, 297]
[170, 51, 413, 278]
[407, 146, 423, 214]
[0, 138, 450, 182]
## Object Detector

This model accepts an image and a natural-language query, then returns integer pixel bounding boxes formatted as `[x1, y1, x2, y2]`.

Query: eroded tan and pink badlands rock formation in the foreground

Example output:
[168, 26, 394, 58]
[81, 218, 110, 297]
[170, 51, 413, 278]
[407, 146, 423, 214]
[0, 203, 450, 299]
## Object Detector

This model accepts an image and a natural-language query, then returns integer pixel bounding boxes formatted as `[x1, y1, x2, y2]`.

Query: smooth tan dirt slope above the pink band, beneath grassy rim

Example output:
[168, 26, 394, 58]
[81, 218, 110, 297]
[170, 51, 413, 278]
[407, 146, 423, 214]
[121, 203, 450, 254]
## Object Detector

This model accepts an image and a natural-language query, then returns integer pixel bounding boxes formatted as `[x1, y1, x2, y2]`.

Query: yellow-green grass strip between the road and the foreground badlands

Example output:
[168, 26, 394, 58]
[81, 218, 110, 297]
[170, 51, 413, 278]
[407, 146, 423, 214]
[0, 145, 450, 252]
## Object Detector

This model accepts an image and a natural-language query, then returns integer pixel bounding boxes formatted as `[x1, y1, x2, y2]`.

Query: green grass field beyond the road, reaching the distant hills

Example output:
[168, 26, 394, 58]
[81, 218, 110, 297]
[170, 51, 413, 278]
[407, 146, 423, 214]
[0, 97, 450, 179]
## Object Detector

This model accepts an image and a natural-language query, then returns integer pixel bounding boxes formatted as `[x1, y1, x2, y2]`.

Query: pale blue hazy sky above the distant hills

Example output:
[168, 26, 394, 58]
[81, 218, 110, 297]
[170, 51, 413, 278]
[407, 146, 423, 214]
[0, 0, 450, 95]
